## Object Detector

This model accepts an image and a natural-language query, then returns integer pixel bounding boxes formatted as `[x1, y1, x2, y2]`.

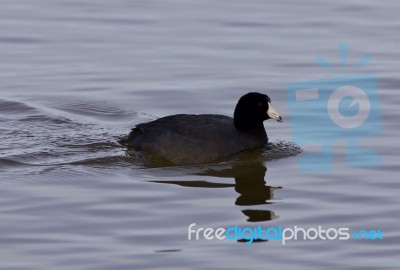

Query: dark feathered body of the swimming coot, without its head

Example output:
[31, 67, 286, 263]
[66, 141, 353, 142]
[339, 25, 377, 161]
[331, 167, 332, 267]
[120, 114, 268, 165]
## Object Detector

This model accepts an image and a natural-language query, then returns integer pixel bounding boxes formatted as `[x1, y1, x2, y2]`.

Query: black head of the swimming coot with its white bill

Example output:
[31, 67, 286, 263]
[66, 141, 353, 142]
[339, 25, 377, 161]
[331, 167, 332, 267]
[233, 92, 282, 131]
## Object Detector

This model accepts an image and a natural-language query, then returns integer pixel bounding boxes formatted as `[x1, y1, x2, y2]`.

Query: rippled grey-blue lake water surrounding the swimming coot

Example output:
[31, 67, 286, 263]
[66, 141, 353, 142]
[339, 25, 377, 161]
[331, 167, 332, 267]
[0, 0, 400, 270]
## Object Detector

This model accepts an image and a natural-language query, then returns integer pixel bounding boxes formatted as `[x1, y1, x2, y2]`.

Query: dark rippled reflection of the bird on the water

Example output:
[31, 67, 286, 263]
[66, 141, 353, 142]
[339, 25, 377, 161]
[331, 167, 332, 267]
[152, 163, 282, 222]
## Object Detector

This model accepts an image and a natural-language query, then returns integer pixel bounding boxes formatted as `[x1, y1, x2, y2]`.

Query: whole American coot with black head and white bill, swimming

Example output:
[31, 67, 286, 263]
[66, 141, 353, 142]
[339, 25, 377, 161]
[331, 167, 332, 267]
[119, 92, 282, 165]
